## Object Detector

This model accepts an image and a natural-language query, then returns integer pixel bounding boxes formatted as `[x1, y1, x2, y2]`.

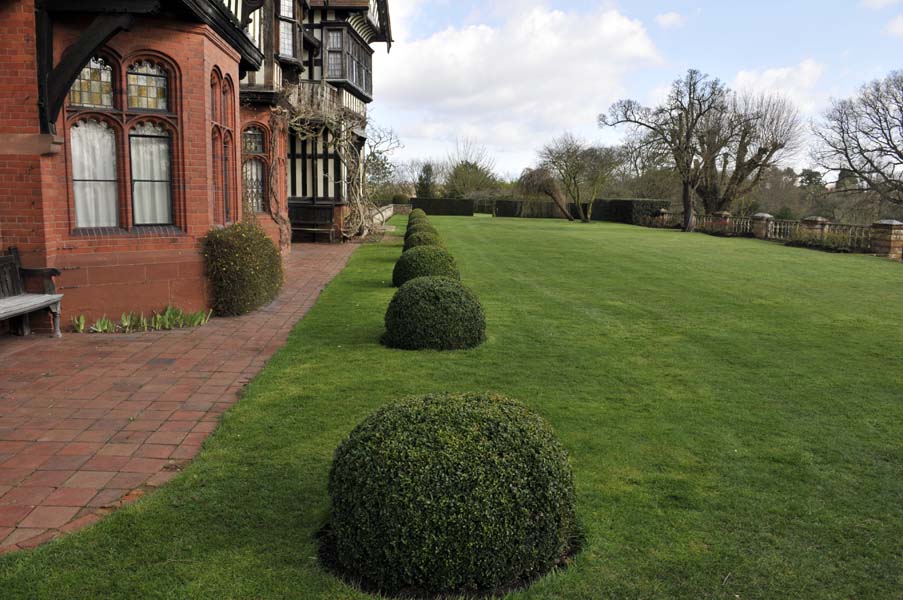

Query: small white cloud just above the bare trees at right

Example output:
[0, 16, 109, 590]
[733, 58, 827, 115]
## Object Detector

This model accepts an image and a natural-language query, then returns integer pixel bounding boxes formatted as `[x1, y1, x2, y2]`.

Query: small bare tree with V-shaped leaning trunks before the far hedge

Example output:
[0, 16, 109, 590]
[539, 133, 621, 223]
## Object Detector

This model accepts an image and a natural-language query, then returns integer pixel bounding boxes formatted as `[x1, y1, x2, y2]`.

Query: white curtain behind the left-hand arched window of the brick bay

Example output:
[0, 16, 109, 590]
[69, 120, 119, 227]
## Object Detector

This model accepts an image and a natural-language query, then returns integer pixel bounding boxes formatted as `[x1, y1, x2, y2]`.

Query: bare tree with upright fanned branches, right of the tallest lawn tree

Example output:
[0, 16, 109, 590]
[696, 94, 802, 213]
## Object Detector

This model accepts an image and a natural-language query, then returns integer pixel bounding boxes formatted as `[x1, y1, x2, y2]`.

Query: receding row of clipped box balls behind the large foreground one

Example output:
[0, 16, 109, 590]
[382, 209, 486, 350]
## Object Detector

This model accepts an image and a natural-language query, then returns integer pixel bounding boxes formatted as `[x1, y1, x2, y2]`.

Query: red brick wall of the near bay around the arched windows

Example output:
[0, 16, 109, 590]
[0, 0, 251, 319]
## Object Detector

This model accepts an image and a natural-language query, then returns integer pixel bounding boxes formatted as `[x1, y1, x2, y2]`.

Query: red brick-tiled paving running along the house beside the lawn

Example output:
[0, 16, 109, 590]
[0, 244, 356, 553]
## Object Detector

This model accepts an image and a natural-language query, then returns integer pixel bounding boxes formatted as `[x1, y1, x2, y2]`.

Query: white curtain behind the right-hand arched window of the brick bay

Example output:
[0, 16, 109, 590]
[129, 124, 172, 225]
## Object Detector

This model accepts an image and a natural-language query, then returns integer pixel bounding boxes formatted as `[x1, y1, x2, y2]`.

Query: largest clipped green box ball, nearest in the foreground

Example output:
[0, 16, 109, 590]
[329, 394, 580, 597]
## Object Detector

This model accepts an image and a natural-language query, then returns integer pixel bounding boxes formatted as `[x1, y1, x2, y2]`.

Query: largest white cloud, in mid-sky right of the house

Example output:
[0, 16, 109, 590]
[374, 5, 662, 169]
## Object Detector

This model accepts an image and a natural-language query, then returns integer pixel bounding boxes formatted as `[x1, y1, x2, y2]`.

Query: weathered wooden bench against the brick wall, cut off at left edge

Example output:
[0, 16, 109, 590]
[0, 248, 63, 337]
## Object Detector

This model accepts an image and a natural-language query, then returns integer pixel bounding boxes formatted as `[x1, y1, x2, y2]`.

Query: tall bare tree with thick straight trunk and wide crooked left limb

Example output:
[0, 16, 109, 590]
[599, 69, 728, 231]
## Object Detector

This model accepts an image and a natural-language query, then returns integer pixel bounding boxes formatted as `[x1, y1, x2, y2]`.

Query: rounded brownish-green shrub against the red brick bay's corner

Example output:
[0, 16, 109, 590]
[203, 222, 283, 316]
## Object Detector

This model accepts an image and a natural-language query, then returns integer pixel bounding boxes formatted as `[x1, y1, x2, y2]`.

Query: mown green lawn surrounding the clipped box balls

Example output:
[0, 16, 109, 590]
[0, 217, 903, 600]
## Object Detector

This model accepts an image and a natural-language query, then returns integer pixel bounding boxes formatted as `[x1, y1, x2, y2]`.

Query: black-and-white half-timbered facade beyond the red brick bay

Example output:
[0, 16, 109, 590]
[241, 0, 392, 239]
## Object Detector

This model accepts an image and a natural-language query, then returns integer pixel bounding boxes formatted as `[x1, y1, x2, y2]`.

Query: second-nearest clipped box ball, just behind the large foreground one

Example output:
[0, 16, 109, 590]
[382, 277, 486, 350]
